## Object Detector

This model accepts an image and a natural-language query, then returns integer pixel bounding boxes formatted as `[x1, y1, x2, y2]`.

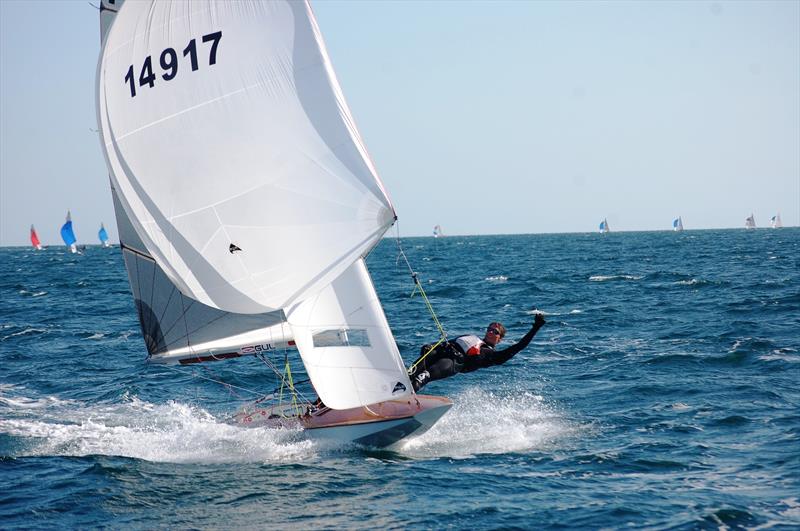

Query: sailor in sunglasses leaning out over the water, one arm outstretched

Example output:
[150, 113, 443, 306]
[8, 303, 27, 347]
[410, 313, 545, 391]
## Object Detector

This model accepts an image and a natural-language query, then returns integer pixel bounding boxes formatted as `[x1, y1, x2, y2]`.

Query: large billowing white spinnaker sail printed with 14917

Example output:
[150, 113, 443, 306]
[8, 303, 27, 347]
[98, 0, 395, 313]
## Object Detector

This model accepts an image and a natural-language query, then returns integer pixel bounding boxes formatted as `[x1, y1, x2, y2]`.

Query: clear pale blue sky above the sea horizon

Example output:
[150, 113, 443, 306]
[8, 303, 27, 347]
[0, 0, 800, 245]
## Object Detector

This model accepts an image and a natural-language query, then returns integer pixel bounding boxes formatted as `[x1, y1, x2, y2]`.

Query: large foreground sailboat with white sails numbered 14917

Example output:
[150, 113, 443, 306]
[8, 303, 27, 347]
[97, 0, 452, 447]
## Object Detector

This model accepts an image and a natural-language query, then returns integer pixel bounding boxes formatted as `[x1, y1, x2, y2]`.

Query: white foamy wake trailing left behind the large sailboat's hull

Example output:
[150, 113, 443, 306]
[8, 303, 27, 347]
[0, 386, 319, 464]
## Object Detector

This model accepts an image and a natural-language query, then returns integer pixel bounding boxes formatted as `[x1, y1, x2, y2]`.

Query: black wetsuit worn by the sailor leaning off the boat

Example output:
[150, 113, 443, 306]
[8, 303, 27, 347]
[410, 322, 544, 391]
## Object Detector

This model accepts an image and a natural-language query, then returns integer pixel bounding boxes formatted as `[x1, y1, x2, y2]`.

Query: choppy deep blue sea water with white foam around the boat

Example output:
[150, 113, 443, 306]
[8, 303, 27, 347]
[0, 228, 800, 529]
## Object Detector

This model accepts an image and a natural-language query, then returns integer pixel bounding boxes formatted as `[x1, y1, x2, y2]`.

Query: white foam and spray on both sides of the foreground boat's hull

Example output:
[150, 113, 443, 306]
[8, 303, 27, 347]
[0, 386, 575, 464]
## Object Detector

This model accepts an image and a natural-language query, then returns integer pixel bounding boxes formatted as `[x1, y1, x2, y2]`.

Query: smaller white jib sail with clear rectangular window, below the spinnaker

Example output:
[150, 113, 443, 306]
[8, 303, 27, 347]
[286, 259, 411, 409]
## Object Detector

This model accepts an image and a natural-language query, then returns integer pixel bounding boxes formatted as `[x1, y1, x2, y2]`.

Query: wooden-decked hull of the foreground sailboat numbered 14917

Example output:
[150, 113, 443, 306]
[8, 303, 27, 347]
[234, 395, 453, 448]
